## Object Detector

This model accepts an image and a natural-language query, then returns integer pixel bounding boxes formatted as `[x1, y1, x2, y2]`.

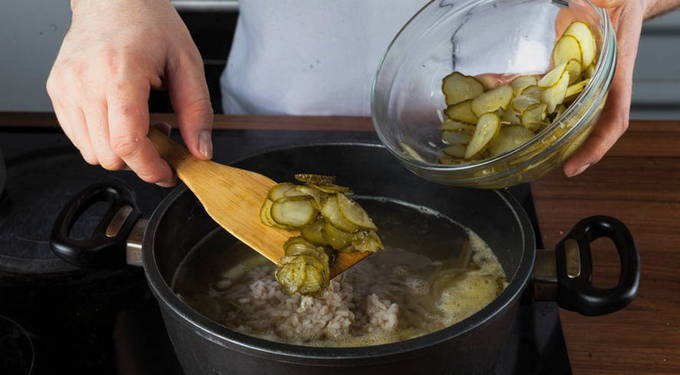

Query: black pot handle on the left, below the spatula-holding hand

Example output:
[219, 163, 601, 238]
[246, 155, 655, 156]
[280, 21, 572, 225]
[50, 183, 141, 268]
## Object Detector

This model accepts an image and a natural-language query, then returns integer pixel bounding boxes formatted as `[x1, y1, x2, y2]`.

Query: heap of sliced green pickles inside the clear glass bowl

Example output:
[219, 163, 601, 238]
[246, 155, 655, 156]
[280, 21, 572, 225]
[437, 21, 598, 164]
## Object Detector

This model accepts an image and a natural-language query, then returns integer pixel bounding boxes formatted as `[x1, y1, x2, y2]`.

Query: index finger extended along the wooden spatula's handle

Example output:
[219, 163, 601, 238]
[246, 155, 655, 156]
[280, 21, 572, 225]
[107, 77, 175, 187]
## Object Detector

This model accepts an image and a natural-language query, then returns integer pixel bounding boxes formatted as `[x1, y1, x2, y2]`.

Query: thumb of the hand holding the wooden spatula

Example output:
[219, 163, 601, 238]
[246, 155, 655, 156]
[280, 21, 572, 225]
[168, 49, 213, 159]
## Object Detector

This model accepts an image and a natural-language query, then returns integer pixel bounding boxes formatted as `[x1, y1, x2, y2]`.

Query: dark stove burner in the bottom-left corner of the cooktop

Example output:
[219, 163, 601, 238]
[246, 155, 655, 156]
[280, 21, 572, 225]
[0, 316, 35, 375]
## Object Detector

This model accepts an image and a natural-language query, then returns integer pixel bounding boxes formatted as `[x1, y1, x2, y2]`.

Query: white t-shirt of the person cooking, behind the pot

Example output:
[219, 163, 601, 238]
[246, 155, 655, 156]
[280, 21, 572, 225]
[221, 0, 427, 116]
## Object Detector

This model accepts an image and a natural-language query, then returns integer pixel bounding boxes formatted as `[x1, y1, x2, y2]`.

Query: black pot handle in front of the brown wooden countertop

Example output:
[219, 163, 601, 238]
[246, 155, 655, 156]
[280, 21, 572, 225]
[555, 216, 640, 315]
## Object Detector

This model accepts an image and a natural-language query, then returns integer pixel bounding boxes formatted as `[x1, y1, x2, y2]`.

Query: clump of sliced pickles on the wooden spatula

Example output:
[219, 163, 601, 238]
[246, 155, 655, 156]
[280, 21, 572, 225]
[260, 178, 383, 296]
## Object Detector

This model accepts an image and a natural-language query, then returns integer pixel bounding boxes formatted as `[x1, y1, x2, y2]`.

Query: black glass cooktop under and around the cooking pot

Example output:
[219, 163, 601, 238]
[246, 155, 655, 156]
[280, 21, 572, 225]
[0, 128, 571, 375]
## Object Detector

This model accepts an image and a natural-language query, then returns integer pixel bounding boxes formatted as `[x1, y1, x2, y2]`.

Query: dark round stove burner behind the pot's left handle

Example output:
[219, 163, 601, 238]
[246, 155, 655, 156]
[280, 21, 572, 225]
[0, 148, 166, 275]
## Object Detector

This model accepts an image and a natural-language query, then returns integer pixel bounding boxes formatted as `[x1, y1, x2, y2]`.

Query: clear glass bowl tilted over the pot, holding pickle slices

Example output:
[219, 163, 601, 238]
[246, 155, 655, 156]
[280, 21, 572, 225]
[371, 0, 616, 188]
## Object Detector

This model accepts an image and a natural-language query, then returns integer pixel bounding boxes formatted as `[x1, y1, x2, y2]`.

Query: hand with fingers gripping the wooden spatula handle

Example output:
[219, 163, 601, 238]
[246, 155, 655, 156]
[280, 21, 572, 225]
[47, 0, 213, 187]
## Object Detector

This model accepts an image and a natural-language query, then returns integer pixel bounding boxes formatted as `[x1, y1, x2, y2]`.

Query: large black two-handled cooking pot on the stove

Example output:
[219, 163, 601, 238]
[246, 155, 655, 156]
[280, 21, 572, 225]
[52, 144, 640, 375]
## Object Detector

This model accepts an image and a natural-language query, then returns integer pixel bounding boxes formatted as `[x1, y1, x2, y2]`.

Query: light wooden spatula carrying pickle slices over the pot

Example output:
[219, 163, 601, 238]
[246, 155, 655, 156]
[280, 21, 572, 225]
[149, 129, 371, 277]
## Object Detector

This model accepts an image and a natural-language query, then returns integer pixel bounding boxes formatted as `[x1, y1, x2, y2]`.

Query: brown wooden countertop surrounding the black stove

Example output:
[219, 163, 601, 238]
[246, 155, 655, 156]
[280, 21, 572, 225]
[0, 113, 680, 375]
